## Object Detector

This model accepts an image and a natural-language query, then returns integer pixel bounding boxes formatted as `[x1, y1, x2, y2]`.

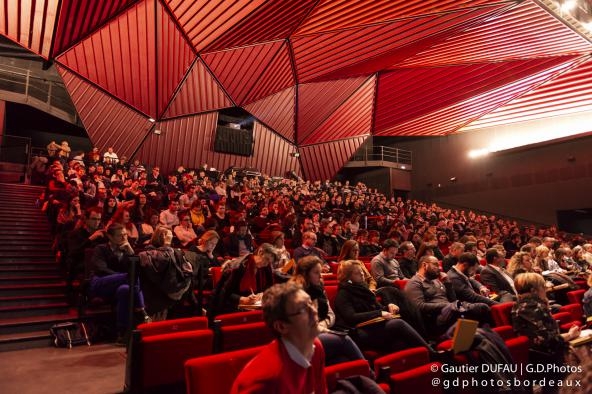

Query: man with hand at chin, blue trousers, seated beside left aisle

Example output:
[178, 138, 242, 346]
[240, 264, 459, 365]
[89, 223, 150, 335]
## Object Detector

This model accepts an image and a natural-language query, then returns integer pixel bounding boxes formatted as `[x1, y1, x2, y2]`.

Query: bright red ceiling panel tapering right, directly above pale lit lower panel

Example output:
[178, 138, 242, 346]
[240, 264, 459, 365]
[374, 56, 572, 135]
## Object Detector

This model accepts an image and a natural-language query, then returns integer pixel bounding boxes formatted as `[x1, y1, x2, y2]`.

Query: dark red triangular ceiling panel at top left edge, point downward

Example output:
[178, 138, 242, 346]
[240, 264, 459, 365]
[52, 0, 139, 56]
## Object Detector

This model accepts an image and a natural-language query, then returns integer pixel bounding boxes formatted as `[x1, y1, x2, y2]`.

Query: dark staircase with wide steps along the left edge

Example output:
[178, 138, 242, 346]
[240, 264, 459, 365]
[0, 183, 77, 351]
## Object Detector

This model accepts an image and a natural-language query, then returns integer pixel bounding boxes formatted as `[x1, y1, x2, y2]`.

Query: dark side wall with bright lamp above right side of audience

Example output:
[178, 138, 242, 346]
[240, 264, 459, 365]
[396, 132, 592, 224]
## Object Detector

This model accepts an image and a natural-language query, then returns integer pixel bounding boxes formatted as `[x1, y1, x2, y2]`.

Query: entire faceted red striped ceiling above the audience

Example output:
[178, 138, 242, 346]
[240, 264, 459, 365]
[0, 0, 592, 177]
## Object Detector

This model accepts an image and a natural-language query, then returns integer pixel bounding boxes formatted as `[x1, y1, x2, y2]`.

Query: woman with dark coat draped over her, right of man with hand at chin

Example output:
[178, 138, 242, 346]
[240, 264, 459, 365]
[138, 227, 193, 321]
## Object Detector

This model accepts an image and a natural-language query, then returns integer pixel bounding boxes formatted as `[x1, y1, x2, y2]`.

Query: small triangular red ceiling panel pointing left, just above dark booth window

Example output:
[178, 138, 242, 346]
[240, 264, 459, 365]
[245, 87, 296, 142]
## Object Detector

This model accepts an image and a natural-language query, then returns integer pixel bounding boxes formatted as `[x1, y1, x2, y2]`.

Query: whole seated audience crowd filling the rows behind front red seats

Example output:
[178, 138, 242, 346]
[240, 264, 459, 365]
[37, 147, 592, 392]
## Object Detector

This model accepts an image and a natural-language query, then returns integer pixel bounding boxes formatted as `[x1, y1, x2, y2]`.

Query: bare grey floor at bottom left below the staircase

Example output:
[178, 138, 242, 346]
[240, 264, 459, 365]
[0, 344, 126, 394]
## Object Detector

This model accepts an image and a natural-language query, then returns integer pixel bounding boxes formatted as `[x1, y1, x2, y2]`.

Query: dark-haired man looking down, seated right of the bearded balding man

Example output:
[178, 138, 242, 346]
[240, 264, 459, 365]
[448, 252, 497, 306]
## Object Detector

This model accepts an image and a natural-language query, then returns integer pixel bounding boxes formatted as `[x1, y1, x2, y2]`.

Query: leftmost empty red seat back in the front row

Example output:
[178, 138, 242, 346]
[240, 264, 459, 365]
[138, 330, 214, 391]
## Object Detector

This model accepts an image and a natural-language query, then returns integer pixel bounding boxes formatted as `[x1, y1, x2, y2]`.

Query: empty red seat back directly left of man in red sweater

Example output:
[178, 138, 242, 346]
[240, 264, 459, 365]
[185, 347, 263, 394]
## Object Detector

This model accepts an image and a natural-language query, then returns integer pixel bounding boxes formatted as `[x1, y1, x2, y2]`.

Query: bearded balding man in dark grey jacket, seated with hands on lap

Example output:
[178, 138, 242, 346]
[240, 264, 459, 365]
[405, 256, 490, 337]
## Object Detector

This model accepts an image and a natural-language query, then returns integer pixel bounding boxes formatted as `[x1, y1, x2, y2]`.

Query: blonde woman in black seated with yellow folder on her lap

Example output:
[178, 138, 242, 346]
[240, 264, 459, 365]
[335, 260, 433, 353]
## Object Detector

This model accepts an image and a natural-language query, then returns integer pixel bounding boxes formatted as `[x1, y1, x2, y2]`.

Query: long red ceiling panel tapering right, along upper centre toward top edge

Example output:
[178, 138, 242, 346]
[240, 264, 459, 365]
[292, 5, 499, 82]
